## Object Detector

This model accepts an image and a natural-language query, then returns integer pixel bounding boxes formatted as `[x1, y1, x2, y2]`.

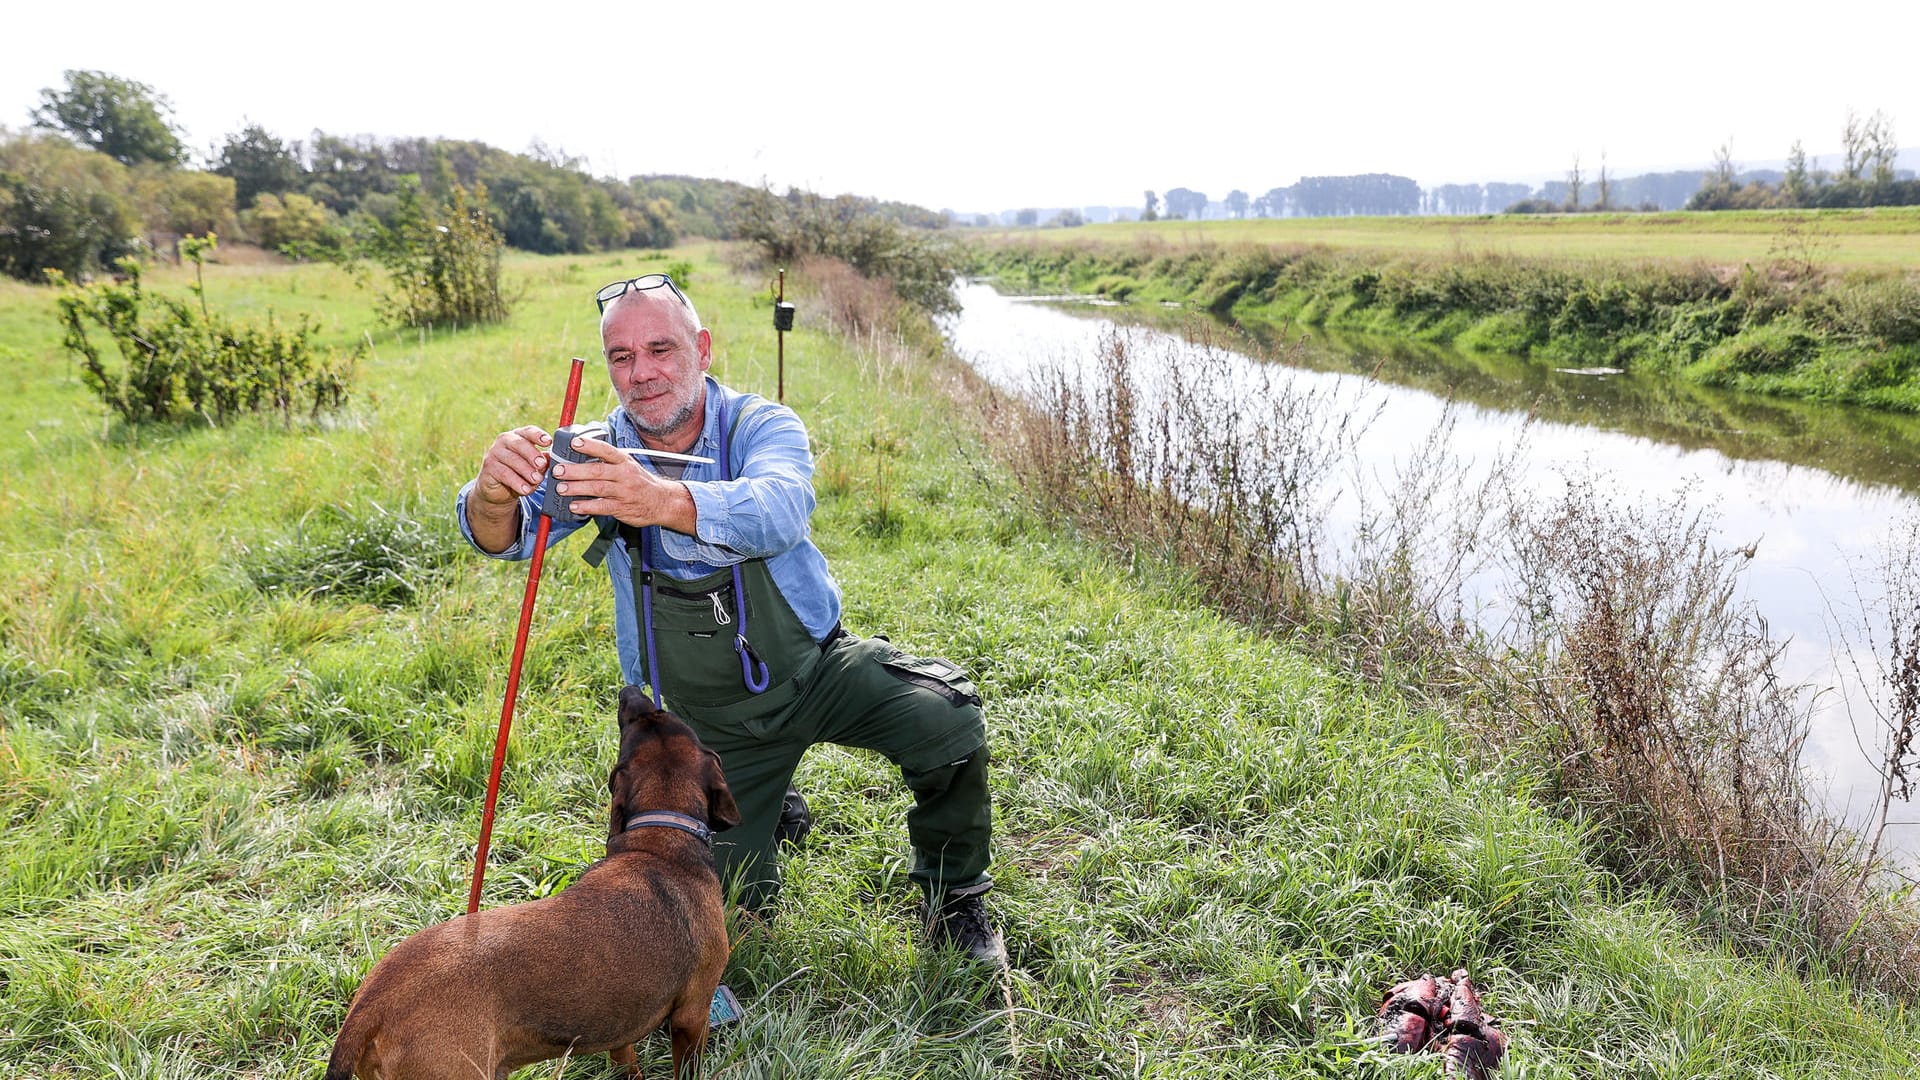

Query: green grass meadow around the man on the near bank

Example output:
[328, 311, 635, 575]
[0, 250, 1920, 1078]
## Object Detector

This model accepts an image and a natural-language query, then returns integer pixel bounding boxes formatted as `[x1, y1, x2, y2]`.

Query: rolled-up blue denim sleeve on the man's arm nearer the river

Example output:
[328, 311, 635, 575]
[660, 405, 814, 567]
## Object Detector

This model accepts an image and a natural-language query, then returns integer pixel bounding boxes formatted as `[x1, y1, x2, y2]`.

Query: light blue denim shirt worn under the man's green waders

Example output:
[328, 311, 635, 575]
[455, 377, 841, 684]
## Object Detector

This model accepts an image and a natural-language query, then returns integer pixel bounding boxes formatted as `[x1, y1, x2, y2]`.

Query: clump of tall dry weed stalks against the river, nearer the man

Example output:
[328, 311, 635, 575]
[1008, 320, 1363, 626]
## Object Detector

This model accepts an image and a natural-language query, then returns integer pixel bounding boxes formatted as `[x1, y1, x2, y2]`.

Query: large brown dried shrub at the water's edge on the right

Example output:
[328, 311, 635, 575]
[1511, 480, 1837, 926]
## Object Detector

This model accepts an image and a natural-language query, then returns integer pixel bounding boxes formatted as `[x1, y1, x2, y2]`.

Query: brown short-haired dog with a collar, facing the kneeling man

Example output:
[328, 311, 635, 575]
[326, 686, 739, 1080]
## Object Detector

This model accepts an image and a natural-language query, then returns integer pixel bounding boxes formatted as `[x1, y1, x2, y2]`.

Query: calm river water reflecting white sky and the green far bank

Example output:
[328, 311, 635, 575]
[945, 282, 1920, 853]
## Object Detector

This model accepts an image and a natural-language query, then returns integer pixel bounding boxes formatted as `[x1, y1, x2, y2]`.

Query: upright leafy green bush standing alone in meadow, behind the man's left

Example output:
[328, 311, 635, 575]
[367, 183, 507, 327]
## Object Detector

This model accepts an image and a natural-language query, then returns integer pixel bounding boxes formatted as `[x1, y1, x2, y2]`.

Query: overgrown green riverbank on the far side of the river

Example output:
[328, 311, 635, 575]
[973, 213, 1920, 411]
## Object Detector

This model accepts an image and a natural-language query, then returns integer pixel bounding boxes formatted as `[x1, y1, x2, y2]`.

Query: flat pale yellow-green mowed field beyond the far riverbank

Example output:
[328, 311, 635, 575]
[966, 208, 1920, 269]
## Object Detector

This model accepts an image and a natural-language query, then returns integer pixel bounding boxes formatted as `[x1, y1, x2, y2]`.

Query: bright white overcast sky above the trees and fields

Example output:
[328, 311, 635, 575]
[0, 0, 1920, 211]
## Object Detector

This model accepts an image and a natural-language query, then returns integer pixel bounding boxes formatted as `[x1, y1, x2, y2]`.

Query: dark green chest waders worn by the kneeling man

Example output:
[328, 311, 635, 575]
[620, 527, 993, 909]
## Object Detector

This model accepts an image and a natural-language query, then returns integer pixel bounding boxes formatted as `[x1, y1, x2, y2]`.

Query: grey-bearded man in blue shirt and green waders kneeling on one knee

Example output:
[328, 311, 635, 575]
[457, 273, 1006, 965]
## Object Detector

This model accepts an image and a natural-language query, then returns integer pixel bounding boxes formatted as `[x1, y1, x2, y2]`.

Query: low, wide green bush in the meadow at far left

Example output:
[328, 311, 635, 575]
[48, 236, 367, 427]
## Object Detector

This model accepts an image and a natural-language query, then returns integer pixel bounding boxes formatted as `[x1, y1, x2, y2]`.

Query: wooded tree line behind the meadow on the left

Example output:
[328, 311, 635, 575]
[0, 71, 945, 279]
